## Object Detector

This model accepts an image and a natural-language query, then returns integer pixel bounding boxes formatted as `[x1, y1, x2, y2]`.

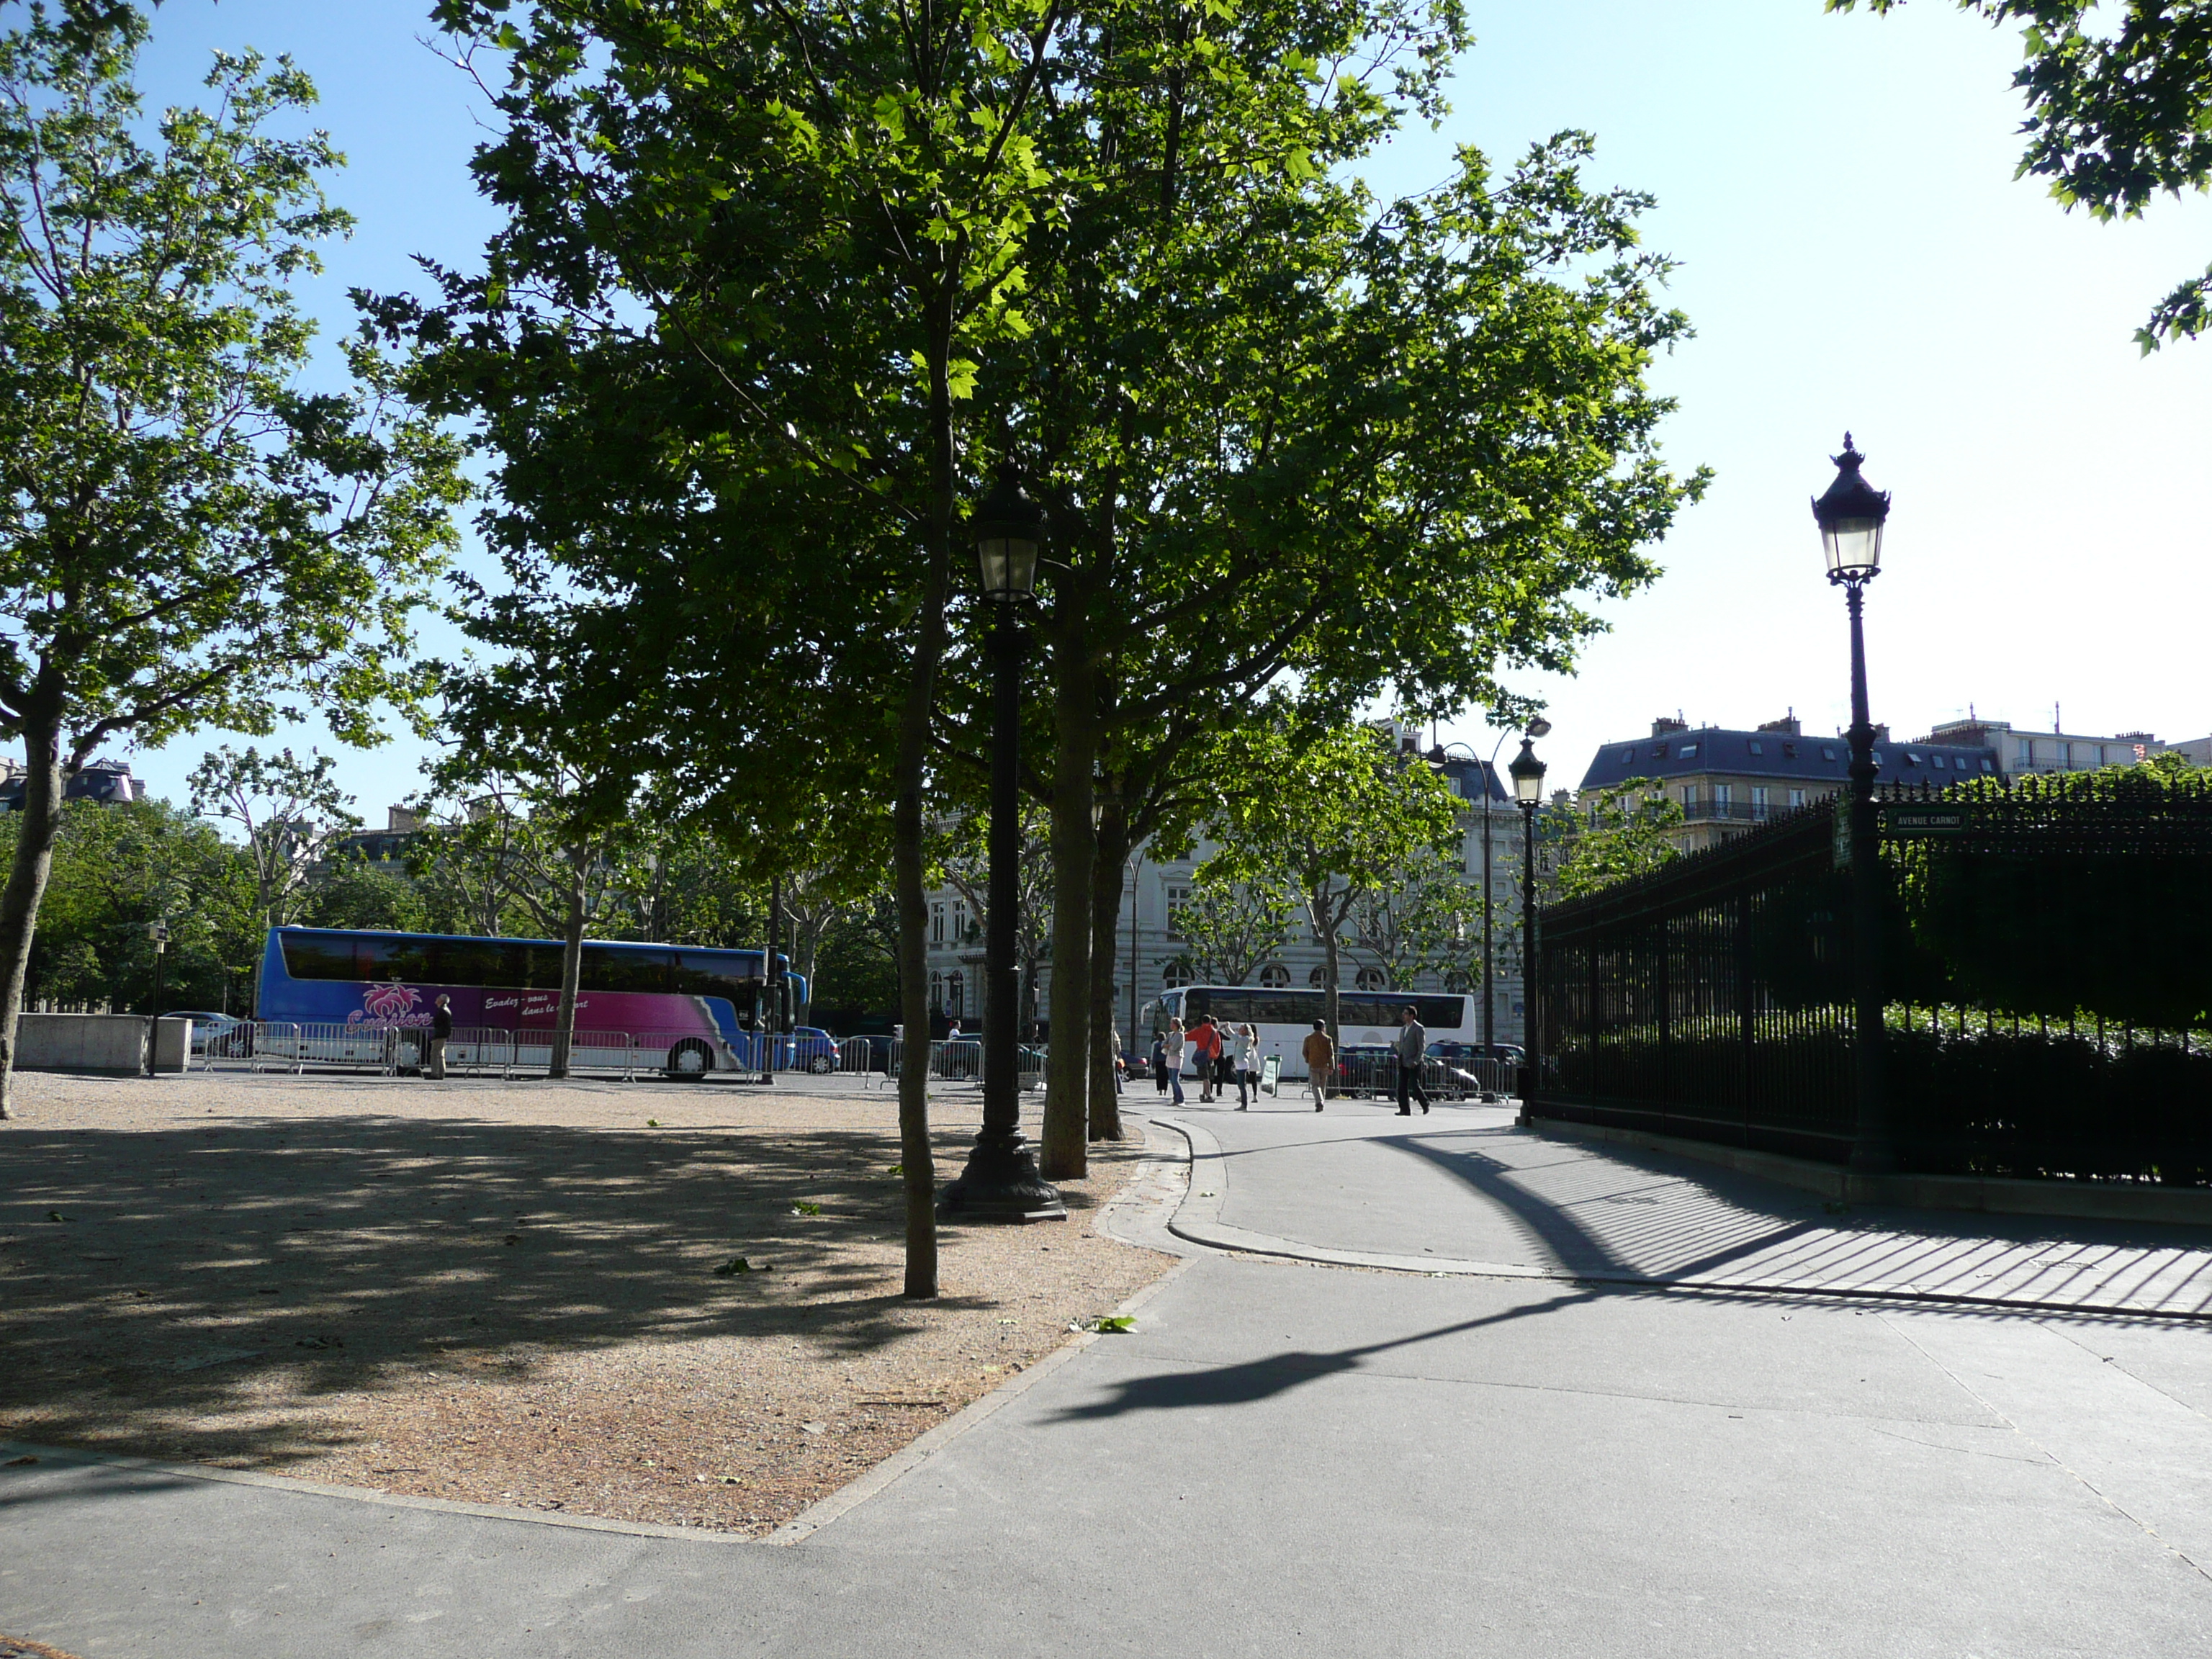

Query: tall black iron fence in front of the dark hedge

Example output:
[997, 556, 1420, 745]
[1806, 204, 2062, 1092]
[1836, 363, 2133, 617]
[1531, 774, 2212, 1186]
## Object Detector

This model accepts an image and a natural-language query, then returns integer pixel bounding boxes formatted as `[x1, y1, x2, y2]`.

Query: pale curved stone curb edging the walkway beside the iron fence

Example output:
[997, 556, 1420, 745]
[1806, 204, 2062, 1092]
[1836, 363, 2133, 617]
[1161, 1119, 2212, 1325]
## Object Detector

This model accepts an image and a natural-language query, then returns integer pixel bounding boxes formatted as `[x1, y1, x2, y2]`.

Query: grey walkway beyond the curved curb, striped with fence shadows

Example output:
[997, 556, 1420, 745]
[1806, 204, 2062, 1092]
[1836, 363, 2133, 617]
[1159, 1102, 2212, 1316]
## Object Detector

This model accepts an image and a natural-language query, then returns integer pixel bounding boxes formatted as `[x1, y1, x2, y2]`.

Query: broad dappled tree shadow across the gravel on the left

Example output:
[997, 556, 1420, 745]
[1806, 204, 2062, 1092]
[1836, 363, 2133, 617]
[0, 1115, 1057, 1460]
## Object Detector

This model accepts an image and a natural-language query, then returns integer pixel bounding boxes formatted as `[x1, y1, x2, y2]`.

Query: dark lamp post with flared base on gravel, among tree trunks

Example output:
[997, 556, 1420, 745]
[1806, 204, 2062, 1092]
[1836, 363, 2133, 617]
[938, 462, 1069, 1221]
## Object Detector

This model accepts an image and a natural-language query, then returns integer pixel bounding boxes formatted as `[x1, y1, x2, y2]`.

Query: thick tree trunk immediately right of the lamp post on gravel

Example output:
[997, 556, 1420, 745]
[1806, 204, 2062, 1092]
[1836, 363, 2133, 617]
[1040, 632, 1100, 1181]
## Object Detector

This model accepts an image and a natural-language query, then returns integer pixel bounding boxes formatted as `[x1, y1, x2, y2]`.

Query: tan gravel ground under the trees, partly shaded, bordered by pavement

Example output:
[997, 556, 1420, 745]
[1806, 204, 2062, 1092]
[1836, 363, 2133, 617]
[0, 1073, 1172, 1533]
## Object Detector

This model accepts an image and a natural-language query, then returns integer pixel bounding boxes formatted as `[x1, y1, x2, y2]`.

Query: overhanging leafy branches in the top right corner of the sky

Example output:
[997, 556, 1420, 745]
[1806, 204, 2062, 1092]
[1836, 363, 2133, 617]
[1825, 0, 2212, 351]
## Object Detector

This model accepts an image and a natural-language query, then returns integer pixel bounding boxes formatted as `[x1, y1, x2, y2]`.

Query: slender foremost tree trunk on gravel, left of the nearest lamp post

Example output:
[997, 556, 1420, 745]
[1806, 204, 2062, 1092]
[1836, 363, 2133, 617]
[891, 292, 953, 1296]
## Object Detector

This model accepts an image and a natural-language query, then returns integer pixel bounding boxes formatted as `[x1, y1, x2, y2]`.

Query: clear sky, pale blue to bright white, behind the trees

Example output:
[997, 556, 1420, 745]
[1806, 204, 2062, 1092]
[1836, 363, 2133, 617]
[135, 0, 2212, 821]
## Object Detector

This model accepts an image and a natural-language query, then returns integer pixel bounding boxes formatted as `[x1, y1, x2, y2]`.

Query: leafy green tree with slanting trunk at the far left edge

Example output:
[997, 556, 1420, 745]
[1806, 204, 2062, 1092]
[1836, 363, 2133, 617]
[0, 4, 460, 1117]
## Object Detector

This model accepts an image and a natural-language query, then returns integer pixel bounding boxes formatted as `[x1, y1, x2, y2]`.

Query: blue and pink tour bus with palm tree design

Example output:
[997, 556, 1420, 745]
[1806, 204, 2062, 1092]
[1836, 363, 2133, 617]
[254, 927, 836, 1077]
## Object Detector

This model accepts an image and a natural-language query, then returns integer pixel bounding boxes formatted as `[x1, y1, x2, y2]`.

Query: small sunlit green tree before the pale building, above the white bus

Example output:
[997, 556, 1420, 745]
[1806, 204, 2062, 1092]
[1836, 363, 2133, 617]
[1205, 726, 1460, 1035]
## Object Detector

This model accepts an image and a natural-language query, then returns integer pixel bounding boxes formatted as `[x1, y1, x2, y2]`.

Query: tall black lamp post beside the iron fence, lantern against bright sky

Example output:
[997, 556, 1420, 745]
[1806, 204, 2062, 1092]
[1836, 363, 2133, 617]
[1812, 431, 1898, 1174]
